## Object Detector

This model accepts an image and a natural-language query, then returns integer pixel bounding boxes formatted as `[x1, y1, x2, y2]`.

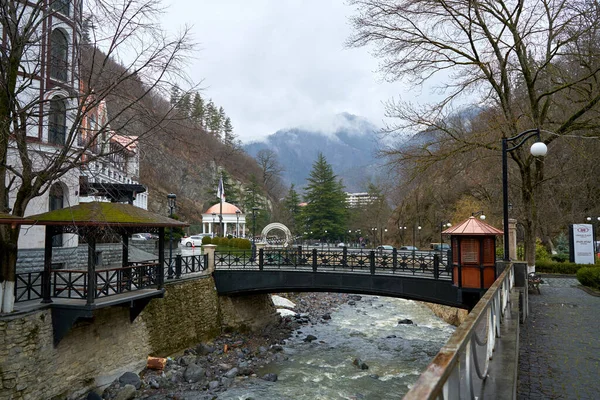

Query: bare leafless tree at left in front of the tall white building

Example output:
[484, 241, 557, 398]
[0, 0, 192, 312]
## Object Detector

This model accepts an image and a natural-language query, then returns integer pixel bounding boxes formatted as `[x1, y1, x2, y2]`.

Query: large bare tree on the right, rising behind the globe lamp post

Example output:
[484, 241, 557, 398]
[349, 0, 600, 265]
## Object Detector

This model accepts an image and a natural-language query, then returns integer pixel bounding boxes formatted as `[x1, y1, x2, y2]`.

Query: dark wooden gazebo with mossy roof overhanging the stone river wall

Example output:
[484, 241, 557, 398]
[28, 202, 188, 343]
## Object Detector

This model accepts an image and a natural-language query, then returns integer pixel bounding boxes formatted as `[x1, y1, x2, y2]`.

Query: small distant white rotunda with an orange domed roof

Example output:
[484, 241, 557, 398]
[202, 202, 246, 237]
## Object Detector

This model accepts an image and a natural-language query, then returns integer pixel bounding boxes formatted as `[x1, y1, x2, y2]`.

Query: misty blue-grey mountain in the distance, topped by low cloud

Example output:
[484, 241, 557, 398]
[244, 113, 382, 192]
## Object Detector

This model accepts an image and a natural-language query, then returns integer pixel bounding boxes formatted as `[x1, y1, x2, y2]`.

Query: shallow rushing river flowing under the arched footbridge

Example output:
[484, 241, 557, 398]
[218, 296, 454, 400]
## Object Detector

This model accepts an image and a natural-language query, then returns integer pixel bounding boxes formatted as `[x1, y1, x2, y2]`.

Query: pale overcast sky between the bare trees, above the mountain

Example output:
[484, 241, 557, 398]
[163, 0, 418, 142]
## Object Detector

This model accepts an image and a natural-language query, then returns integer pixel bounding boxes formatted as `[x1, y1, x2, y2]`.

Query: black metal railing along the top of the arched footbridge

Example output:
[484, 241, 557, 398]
[215, 247, 452, 280]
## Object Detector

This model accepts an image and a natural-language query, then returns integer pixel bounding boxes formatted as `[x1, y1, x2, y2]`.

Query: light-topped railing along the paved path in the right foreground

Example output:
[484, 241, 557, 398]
[404, 263, 514, 400]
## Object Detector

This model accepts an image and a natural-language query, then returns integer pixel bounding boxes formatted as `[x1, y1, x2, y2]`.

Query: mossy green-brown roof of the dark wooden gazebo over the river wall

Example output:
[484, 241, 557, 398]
[27, 202, 189, 227]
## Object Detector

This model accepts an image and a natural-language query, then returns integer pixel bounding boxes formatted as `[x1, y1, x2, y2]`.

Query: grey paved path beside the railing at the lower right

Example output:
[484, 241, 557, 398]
[517, 277, 600, 399]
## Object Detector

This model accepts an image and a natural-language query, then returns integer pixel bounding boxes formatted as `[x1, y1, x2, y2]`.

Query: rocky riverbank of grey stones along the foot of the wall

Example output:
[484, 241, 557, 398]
[84, 293, 355, 400]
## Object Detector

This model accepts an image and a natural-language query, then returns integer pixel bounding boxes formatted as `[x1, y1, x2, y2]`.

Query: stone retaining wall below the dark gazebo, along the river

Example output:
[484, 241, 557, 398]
[0, 275, 275, 400]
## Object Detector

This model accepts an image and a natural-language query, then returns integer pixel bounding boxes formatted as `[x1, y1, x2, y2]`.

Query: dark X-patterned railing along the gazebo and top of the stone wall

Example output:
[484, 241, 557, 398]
[14, 254, 208, 302]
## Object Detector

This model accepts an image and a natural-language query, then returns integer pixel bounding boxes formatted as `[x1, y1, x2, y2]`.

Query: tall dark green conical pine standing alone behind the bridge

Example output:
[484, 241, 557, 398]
[302, 153, 348, 240]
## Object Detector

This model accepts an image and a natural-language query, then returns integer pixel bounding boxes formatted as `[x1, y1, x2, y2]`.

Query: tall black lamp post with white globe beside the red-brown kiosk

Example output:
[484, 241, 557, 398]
[502, 129, 548, 261]
